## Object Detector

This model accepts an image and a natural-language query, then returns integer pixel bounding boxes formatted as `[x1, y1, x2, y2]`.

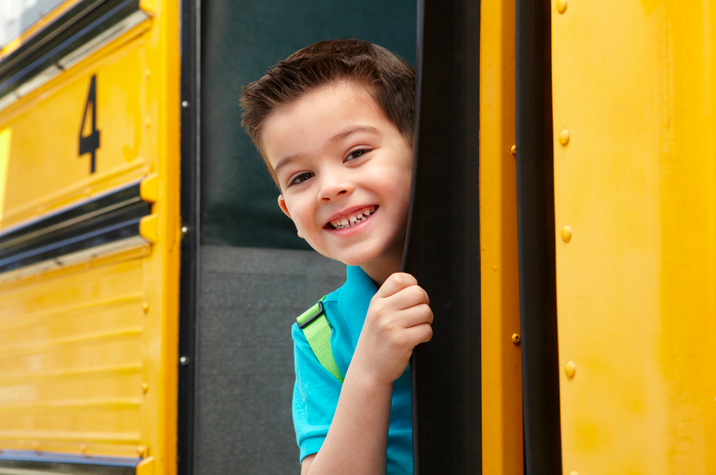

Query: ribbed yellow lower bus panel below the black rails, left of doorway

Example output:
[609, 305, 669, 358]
[0, 245, 149, 457]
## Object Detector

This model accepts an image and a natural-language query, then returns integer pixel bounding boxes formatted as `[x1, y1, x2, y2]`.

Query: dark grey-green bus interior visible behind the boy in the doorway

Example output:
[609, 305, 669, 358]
[194, 0, 416, 475]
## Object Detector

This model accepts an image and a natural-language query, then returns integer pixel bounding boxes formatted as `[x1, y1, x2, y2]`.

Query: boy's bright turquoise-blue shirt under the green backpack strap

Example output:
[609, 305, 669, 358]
[291, 267, 413, 475]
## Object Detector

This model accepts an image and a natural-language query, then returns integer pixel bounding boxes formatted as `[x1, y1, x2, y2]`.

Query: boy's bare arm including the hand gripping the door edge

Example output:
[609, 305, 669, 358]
[301, 273, 433, 475]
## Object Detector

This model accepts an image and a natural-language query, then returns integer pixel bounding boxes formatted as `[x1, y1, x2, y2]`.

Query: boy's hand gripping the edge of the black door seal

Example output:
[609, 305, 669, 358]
[351, 273, 433, 384]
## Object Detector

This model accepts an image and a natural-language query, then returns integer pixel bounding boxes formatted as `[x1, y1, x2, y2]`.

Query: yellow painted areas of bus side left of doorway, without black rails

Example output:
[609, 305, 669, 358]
[0, 0, 181, 475]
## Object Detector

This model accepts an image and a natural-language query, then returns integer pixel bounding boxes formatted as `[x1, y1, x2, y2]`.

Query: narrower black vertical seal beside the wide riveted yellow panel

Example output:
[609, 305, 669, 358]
[515, 0, 562, 475]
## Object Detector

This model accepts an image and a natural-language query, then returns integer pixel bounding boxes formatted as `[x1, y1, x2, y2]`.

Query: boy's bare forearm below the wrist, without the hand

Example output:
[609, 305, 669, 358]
[301, 361, 393, 475]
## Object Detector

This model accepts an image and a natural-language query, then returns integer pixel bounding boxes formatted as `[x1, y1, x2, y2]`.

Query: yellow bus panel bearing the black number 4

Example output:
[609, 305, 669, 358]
[0, 26, 151, 230]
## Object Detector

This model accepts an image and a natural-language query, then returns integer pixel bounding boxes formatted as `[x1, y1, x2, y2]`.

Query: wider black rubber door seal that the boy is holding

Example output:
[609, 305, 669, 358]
[403, 0, 482, 475]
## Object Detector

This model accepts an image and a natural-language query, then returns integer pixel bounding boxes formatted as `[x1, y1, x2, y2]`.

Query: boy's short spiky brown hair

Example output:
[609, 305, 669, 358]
[241, 38, 415, 181]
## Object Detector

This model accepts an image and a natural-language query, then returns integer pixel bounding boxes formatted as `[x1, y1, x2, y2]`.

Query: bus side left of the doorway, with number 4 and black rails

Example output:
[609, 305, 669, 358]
[0, 0, 180, 473]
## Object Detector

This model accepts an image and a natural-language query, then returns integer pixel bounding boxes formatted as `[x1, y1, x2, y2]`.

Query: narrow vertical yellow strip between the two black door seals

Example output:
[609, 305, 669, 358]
[480, 1, 523, 475]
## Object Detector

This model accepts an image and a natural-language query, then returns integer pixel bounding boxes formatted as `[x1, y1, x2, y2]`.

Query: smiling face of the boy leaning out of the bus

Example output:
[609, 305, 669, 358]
[262, 82, 413, 279]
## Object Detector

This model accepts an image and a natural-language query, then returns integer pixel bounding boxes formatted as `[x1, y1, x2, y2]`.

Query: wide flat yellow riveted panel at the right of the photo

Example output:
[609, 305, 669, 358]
[552, 0, 716, 475]
